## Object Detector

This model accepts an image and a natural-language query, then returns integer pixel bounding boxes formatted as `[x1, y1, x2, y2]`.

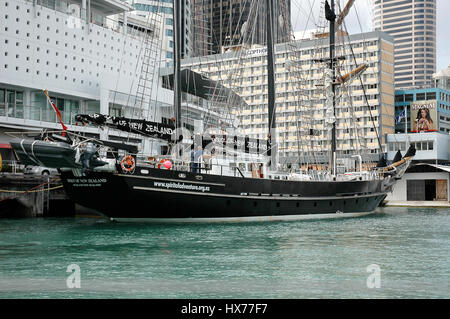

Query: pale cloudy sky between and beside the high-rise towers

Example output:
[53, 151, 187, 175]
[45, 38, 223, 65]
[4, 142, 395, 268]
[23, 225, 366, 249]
[291, 0, 450, 71]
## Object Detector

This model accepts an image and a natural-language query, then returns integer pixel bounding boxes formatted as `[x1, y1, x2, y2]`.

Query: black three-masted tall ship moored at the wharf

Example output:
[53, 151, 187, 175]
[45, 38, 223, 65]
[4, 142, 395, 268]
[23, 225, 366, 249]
[7, 0, 415, 222]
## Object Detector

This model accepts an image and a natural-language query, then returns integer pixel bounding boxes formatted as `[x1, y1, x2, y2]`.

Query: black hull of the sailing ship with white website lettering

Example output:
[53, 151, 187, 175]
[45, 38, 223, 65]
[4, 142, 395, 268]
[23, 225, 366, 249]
[61, 168, 386, 222]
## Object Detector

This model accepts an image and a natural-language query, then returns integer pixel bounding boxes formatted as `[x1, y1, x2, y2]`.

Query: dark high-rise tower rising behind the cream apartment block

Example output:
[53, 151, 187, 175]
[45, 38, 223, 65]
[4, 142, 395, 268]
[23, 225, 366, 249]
[192, 0, 291, 56]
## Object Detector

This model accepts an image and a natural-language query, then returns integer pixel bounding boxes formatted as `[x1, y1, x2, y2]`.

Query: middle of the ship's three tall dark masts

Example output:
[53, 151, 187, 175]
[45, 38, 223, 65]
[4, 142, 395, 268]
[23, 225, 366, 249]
[266, 0, 278, 170]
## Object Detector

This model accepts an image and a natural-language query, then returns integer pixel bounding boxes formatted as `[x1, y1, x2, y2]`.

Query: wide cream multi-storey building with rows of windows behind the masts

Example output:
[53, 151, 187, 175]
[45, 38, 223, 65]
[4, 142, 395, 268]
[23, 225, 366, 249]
[183, 31, 394, 164]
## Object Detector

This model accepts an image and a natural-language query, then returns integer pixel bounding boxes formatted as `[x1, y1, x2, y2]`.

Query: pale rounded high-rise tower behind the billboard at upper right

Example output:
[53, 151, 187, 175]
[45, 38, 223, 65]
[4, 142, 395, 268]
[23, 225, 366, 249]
[373, 0, 436, 89]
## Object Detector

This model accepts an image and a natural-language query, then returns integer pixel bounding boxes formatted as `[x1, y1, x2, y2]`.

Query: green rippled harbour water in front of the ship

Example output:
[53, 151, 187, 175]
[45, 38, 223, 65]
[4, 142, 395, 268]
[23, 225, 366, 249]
[0, 208, 450, 299]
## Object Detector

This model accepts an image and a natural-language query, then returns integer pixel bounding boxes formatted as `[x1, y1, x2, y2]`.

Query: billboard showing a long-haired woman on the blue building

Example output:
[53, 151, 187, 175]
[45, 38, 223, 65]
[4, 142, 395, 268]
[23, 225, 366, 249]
[411, 100, 438, 133]
